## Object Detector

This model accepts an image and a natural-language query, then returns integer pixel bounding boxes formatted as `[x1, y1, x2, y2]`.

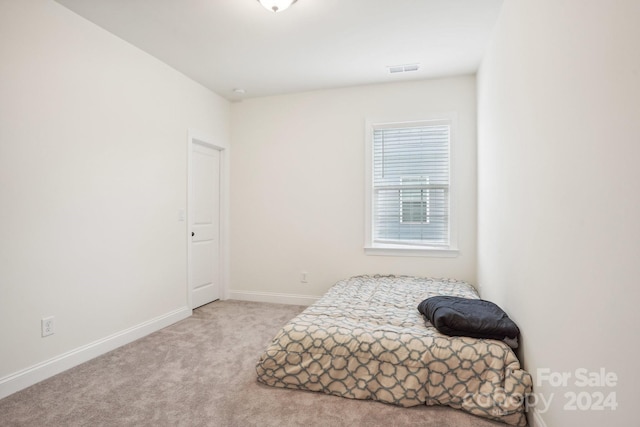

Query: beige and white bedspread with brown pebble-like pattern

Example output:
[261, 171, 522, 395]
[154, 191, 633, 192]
[256, 276, 532, 426]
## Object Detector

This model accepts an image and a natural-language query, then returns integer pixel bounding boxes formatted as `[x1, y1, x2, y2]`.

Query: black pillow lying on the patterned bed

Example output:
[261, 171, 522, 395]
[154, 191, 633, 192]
[418, 296, 520, 340]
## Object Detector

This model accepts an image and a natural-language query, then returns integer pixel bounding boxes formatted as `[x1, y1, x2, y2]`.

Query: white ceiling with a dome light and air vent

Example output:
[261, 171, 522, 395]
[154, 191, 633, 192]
[56, 0, 502, 101]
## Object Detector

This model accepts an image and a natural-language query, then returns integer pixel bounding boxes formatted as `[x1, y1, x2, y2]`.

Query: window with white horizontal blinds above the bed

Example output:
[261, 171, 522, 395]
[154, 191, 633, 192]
[365, 118, 456, 255]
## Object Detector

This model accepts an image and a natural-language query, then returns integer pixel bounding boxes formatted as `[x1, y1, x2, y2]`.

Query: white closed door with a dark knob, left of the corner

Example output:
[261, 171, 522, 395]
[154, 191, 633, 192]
[189, 140, 220, 308]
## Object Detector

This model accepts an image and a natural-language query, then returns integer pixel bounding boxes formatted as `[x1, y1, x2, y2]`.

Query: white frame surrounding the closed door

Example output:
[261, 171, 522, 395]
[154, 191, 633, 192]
[185, 129, 229, 309]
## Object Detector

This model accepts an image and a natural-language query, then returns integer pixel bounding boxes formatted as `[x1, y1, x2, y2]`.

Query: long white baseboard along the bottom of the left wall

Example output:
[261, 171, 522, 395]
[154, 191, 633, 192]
[0, 307, 192, 399]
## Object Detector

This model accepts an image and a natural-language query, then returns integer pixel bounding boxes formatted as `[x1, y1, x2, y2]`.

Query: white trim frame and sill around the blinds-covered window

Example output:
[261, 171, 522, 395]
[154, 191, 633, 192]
[364, 113, 459, 257]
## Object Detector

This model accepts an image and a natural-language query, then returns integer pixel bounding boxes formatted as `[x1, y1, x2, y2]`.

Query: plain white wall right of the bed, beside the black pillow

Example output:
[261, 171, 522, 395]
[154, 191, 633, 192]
[478, 0, 640, 426]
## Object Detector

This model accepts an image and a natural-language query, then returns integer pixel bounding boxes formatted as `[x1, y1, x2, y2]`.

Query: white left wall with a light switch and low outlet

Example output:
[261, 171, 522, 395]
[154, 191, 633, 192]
[0, 0, 229, 397]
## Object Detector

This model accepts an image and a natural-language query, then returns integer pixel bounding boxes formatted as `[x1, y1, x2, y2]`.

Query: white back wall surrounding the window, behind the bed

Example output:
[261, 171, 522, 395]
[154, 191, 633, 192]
[230, 76, 476, 303]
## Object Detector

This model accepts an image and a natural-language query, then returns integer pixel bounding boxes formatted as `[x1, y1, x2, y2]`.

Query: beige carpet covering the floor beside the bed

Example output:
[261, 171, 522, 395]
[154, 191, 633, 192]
[0, 301, 504, 427]
